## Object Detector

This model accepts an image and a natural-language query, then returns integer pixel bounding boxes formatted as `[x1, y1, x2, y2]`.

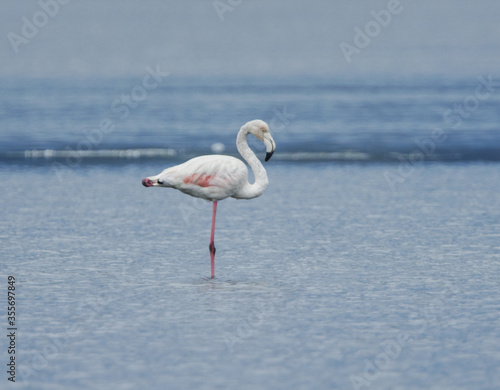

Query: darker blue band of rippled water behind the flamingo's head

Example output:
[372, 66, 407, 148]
[0, 75, 500, 161]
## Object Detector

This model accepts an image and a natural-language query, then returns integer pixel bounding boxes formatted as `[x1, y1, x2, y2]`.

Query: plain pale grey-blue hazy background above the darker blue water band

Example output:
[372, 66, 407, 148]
[0, 0, 500, 79]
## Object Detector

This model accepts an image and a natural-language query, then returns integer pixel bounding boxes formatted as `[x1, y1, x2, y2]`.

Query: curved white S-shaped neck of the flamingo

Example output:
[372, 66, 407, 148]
[234, 127, 269, 199]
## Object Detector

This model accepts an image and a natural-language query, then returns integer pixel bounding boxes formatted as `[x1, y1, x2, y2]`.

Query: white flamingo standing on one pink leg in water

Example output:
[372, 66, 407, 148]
[142, 119, 276, 279]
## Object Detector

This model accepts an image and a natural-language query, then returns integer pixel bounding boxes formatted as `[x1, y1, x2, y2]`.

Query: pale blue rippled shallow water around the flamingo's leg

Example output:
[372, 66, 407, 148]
[0, 160, 500, 390]
